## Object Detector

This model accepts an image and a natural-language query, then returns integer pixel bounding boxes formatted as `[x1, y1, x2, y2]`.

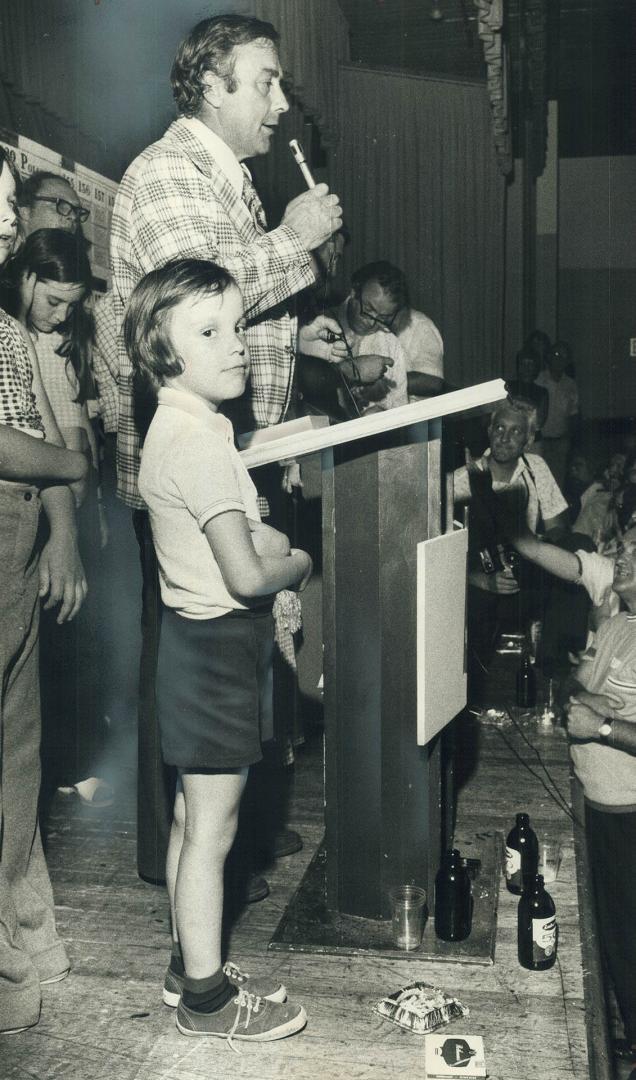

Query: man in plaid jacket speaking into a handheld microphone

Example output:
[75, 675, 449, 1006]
[111, 15, 341, 879]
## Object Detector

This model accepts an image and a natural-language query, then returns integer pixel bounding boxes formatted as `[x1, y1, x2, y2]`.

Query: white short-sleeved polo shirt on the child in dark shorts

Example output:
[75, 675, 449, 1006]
[139, 387, 260, 619]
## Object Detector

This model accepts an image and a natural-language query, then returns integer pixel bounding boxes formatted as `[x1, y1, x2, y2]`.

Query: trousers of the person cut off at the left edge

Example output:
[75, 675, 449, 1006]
[0, 483, 68, 1031]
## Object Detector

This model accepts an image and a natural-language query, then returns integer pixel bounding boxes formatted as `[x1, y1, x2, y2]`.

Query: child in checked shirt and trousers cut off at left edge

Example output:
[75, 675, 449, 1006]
[0, 147, 86, 1035]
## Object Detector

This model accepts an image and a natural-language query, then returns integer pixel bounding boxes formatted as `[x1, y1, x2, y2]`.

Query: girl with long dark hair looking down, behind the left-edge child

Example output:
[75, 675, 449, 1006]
[8, 229, 112, 806]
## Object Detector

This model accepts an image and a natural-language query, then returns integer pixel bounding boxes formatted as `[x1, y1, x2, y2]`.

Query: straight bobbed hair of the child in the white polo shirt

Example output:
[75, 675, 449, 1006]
[123, 259, 236, 400]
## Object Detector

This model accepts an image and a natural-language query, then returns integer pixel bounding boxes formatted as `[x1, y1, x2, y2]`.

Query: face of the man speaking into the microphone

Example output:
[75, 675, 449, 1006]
[211, 38, 289, 161]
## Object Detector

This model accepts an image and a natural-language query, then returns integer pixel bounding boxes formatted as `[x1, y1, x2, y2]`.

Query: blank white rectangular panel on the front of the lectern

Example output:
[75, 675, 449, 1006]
[417, 529, 468, 746]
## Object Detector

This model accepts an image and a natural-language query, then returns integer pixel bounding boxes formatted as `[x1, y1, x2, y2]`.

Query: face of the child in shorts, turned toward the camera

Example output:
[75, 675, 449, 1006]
[166, 286, 249, 411]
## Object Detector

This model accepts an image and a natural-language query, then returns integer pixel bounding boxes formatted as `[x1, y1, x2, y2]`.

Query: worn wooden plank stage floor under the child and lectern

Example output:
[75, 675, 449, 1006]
[0, 695, 588, 1080]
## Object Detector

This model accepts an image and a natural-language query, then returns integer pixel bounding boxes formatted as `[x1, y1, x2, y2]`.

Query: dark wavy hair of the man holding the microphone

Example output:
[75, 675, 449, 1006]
[171, 15, 280, 117]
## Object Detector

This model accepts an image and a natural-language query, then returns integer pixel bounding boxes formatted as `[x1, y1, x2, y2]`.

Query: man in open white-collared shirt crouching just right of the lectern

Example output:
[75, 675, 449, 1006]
[455, 399, 587, 700]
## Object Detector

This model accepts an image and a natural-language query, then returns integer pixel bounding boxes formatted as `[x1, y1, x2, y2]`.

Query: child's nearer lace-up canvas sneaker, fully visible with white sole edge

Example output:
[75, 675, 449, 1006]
[177, 990, 307, 1049]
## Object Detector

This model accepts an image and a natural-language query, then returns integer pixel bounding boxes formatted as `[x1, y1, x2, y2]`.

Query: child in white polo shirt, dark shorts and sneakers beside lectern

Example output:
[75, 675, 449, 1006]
[124, 259, 311, 1041]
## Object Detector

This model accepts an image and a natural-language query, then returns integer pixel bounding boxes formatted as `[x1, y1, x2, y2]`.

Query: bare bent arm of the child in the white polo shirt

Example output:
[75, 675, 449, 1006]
[204, 510, 311, 598]
